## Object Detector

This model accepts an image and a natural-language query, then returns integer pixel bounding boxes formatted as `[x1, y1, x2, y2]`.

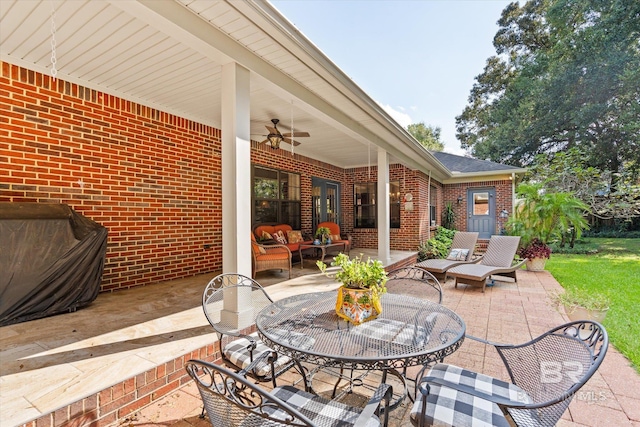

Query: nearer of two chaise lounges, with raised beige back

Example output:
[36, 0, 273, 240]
[447, 236, 526, 292]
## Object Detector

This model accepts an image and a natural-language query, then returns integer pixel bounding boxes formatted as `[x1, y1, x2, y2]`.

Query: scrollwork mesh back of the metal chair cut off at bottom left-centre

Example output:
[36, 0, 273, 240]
[185, 360, 314, 427]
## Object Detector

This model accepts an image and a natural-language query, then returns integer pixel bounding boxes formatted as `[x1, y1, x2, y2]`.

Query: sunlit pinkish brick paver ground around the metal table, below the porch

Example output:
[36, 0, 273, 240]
[126, 270, 640, 427]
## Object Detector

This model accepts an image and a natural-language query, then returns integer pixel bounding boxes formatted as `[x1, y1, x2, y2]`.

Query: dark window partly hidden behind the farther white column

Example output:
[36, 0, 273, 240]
[353, 181, 400, 228]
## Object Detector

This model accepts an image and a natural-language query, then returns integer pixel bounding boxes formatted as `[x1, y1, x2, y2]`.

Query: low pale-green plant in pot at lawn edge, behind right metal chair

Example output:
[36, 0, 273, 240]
[550, 287, 611, 322]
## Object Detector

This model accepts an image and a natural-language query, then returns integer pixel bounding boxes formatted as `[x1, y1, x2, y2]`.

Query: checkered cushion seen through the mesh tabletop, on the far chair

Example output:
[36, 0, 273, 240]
[351, 313, 437, 346]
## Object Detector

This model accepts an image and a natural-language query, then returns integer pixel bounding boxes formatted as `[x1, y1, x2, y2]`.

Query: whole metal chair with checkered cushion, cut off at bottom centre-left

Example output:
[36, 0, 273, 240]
[185, 360, 392, 427]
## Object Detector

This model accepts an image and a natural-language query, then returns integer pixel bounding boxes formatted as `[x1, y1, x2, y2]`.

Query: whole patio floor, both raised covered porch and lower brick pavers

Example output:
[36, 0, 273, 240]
[0, 249, 640, 426]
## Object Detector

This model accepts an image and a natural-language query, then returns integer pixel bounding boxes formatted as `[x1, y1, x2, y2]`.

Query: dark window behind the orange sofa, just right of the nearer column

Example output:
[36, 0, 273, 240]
[253, 166, 301, 230]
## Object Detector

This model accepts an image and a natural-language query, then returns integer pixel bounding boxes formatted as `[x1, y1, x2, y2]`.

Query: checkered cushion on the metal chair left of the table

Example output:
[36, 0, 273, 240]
[222, 330, 315, 377]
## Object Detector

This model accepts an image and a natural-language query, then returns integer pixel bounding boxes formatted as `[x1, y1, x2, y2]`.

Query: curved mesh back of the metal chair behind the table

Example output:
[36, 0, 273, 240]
[386, 267, 442, 304]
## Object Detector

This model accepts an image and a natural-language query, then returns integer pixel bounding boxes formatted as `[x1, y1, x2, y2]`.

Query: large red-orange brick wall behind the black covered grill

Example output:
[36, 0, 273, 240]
[0, 63, 222, 291]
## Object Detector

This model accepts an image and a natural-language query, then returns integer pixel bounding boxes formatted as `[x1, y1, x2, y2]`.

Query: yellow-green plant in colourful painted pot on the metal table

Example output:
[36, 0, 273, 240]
[316, 253, 388, 325]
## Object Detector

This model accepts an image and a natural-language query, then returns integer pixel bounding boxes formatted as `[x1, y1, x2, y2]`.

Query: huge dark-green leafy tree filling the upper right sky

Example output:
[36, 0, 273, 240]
[456, 0, 640, 179]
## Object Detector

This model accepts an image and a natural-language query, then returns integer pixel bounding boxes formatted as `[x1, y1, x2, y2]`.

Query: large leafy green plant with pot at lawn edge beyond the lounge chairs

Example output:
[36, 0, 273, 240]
[505, 183, 589, 271]
